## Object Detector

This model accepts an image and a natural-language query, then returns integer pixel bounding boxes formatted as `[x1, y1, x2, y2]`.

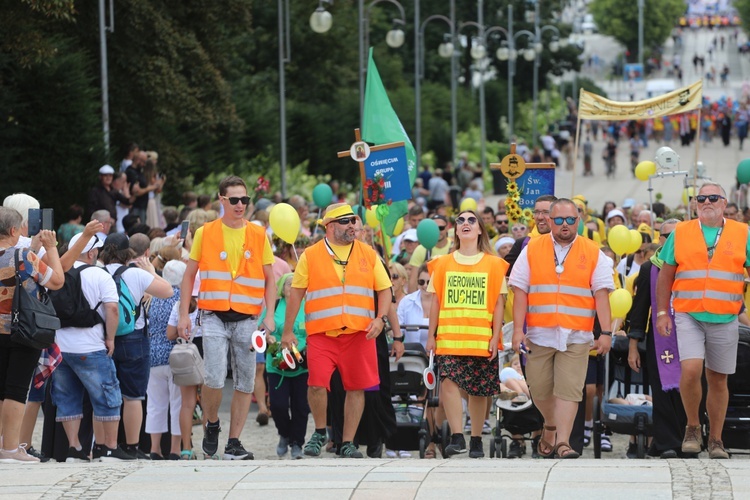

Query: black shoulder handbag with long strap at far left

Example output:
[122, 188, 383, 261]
[10, 248, 60, 349]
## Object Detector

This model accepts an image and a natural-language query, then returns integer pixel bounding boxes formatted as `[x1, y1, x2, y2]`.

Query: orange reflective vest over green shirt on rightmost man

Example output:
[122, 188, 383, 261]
[672, 219, 748, 314]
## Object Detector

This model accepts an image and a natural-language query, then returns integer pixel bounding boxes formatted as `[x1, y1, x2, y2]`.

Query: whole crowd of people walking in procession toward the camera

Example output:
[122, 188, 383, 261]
[0, 137, 750, 463]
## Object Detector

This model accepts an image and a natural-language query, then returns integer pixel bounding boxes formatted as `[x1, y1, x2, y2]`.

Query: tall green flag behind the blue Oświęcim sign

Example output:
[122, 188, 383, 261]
[362, 48, 417, 235]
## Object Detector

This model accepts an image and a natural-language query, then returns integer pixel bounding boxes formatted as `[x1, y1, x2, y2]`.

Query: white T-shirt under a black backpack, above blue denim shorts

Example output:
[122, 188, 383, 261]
[55, 261, 119, 354]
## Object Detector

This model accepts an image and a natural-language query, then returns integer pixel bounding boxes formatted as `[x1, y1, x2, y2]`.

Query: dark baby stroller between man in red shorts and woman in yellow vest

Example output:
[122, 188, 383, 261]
[386, 325, 440, 458]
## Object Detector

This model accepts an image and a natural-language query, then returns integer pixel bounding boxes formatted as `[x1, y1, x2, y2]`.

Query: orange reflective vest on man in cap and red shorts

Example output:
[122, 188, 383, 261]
[305, 241, 379, 335]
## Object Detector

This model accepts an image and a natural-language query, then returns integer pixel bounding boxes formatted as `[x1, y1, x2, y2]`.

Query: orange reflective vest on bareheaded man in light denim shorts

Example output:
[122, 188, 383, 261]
[198, 219, 266, 314]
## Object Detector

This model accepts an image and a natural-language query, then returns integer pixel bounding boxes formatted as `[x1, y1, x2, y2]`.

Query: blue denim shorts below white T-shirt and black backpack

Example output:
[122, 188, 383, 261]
[52, 350, 122, 422]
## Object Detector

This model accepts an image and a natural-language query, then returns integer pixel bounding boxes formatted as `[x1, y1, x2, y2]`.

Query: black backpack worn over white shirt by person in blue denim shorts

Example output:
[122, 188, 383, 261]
[48, 265, 104, 328]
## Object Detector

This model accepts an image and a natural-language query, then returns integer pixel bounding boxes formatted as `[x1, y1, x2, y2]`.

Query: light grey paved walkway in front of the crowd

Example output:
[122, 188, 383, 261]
[0, 459, 750, 500]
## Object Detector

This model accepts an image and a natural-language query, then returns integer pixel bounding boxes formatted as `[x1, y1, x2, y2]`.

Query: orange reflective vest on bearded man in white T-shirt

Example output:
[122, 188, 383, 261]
[526, 236, 599, 332]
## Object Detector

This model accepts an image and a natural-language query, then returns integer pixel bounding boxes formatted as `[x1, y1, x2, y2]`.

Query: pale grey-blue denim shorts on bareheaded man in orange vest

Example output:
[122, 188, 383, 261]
[201, 311, 258, 394]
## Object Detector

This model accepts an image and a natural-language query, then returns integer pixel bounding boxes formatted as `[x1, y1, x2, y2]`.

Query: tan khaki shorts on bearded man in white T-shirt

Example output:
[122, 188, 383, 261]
[526, 339, 591, 402]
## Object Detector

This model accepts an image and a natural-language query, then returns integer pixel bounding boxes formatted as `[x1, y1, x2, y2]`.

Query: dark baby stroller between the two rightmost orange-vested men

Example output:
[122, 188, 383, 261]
[592, 336, 653, 458]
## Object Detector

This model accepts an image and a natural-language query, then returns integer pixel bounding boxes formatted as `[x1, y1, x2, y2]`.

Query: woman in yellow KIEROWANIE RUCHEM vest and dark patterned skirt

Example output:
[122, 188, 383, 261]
[426, 210, 508, 458]
